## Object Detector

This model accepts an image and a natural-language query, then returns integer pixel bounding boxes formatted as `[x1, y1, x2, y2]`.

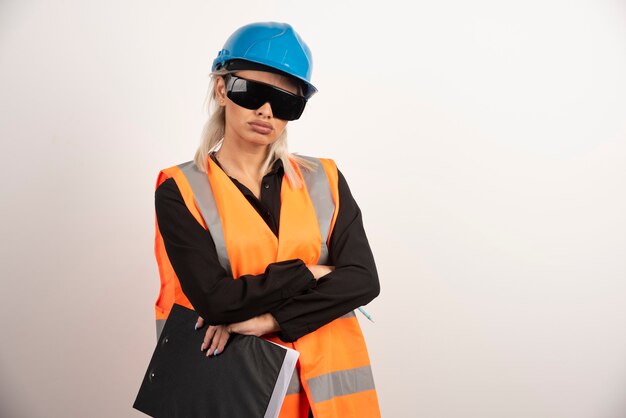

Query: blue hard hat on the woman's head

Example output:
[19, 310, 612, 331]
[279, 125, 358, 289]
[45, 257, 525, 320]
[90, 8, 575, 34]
[211, 22, 317, 99]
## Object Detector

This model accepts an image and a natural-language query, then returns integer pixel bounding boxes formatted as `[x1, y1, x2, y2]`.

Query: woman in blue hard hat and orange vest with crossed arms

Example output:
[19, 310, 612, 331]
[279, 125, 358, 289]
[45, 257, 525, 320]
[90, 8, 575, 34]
[155, 23, 380, 417]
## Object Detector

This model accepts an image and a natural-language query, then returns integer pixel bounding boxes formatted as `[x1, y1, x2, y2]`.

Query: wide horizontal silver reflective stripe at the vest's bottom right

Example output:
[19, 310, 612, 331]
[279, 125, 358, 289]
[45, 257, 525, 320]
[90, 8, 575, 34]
[307, 366, 375, 403]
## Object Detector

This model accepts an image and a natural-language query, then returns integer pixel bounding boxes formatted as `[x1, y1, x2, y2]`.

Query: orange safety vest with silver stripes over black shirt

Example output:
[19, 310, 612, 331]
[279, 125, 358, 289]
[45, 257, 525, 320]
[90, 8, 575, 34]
[155, 156, 380, 418]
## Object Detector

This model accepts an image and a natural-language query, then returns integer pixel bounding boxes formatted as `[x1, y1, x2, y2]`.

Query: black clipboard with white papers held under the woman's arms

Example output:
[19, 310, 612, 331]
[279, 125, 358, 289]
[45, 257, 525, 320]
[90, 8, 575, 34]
[133, 304, 297, 418]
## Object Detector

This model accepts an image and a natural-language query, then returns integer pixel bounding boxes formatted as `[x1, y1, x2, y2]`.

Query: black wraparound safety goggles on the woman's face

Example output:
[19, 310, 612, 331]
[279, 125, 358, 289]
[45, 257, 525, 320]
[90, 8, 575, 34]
[225, 74, 306, 120]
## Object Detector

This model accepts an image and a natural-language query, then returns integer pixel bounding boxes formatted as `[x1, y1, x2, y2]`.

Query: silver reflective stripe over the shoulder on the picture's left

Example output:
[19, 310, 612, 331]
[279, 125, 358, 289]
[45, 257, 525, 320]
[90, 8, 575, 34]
[178, 161, 232, 275]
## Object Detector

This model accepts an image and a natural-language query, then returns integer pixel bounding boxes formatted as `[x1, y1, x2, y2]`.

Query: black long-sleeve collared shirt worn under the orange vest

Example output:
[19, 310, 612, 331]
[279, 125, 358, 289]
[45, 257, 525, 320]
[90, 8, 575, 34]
[155, 155, 380, 341]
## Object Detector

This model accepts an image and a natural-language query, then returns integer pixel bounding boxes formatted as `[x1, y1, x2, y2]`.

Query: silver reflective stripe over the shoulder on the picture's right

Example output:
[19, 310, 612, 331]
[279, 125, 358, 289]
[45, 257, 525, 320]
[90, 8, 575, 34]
[298, 155, 335, 265]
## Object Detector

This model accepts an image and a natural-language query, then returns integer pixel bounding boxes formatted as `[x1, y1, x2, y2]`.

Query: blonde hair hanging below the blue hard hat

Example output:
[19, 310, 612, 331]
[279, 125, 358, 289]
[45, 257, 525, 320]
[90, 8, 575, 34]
[194, 69, 317, 188]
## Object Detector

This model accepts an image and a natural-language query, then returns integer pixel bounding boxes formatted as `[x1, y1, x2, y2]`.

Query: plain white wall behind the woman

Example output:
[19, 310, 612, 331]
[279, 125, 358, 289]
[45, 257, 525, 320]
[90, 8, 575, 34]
[0, 0, 626, 418]
